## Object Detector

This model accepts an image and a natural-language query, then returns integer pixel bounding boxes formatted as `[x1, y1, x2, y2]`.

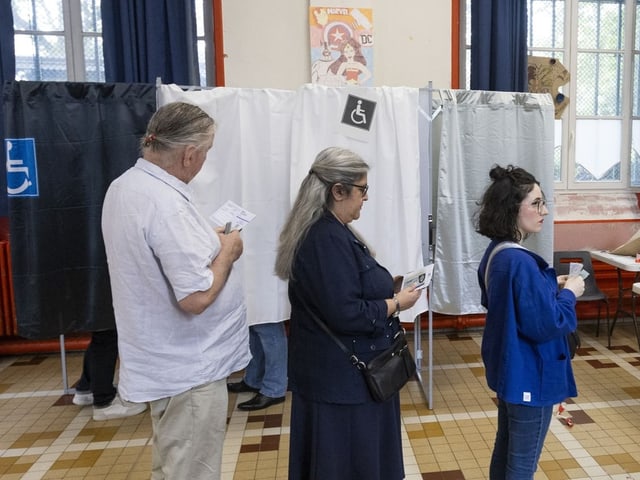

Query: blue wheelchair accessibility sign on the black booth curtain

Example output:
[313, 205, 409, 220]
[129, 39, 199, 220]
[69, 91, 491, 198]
[4, 138, 39, 197]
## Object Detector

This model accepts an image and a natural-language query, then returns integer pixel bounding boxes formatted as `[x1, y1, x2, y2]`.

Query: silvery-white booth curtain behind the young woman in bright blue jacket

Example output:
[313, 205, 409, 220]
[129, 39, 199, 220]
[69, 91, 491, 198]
[430, 90, 554, 315]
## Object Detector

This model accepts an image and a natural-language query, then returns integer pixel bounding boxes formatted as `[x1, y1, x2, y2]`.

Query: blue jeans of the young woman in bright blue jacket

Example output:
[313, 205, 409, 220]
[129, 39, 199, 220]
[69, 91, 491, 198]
[489, 399, 553, 480]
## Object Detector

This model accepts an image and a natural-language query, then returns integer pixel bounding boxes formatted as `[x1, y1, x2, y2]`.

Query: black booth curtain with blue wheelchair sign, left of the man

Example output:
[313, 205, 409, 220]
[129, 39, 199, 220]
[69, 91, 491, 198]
[3, 82, 156, 339]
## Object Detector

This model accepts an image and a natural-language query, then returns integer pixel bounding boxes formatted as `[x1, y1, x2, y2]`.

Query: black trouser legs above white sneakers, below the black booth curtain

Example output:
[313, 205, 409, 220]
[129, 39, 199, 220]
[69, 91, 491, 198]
[86, 329, 118, 407]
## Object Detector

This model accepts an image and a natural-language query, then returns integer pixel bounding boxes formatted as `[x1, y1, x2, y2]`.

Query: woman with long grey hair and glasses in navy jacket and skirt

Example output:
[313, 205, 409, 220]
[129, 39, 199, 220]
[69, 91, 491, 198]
[275, 147, 421, 480]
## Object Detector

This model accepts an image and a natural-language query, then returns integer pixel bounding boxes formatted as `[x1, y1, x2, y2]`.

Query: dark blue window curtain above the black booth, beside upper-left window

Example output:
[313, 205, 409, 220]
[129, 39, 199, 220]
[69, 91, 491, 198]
[101, 0, 200, 85]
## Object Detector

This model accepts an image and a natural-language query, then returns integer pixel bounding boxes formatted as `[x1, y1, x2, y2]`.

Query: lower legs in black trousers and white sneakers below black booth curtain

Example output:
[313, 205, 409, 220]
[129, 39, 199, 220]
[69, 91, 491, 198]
[72, 325, 147, 421]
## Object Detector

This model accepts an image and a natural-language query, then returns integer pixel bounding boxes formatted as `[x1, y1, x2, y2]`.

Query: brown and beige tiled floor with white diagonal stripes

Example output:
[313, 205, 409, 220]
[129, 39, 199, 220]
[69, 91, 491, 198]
[0, 320, 640, 480]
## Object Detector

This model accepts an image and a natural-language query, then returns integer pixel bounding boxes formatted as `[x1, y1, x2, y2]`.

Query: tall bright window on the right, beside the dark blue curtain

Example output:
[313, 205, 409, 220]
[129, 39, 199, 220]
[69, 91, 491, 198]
[465, 0, 640, 190]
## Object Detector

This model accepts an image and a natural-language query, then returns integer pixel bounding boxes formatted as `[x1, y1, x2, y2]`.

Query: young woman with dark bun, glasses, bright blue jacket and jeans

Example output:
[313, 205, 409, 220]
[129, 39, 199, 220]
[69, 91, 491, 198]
[474, 165, 584, 480]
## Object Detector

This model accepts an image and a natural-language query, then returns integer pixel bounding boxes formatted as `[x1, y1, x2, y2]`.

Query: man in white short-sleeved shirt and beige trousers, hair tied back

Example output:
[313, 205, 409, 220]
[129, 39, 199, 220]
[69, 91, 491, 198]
[102, 102, 250, 480]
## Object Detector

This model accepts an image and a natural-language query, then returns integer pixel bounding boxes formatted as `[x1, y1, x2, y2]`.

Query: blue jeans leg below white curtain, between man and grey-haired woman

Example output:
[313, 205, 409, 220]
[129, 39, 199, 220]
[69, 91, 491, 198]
[244, 322, 287, 398]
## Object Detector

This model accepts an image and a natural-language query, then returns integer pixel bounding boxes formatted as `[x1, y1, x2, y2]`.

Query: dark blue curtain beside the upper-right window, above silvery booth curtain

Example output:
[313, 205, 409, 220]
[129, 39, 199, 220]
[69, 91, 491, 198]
[471, 0, 529, 92]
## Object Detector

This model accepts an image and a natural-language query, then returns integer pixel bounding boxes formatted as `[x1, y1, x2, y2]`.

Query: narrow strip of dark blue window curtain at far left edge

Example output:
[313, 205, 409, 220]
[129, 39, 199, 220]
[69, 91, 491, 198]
[0, 0, 16, 217]
